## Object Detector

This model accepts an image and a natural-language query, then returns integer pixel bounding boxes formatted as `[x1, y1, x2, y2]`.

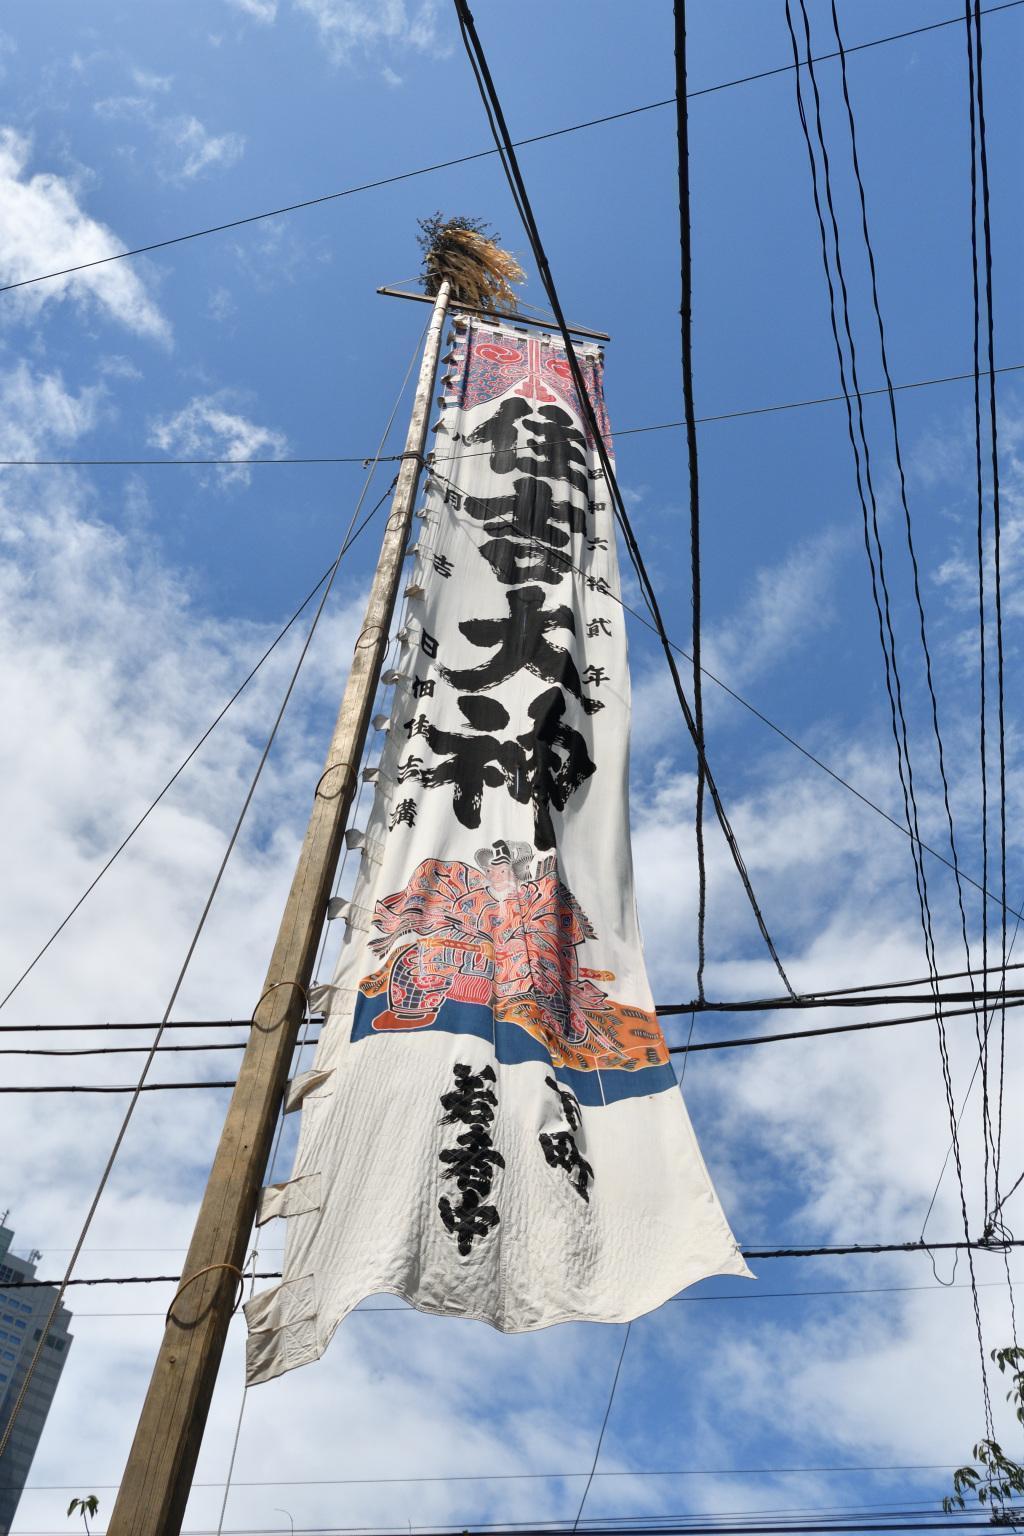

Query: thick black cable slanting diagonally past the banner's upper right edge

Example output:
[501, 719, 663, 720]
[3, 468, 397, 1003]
[454, 0, 792, 992]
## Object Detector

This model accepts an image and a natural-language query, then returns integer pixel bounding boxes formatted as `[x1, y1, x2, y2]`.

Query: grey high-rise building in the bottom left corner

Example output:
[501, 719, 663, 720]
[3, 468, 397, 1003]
[0, 1224, 71, 1536]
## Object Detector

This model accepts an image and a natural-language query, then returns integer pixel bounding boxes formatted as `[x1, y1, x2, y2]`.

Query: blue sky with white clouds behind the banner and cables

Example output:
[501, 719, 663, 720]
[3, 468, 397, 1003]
[0, 0, 1024, 1533]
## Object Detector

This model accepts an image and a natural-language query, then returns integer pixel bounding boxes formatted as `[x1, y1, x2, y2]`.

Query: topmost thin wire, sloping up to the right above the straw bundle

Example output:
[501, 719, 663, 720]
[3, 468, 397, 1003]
[0, 0, 1024, 299]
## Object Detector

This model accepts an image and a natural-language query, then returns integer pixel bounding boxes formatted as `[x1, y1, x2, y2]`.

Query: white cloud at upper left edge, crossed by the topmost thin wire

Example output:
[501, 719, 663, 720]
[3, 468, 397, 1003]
[0, 127, 170, 343]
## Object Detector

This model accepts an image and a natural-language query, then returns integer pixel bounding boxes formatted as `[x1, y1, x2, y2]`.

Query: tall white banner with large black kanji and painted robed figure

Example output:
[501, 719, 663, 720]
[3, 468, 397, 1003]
[246, 316, 749, 1382]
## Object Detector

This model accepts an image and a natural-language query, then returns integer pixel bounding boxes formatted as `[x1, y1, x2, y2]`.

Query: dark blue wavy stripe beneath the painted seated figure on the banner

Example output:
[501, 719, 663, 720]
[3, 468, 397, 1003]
[352, 992, 676, 1104]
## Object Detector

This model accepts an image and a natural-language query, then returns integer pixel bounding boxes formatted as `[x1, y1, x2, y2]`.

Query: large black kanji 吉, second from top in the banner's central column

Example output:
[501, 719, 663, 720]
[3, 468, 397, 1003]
[465, 479, 586, 587]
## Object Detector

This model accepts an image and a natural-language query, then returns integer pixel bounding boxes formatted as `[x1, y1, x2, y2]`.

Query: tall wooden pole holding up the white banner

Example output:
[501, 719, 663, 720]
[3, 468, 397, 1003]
[107, 283, 450, 1536]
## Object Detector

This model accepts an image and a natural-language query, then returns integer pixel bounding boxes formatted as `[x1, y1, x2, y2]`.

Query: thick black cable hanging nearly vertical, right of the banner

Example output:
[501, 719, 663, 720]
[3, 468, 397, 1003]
[675, 0, 708, 1007]
